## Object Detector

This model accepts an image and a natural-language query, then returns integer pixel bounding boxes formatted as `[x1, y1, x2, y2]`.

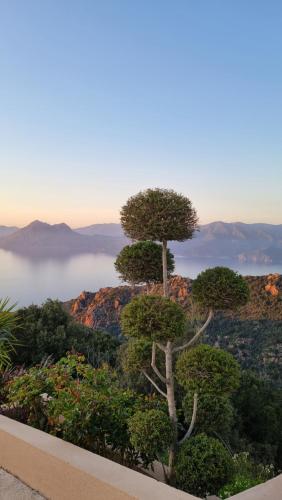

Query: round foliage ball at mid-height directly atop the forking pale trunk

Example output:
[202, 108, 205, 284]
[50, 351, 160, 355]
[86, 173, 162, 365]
[121, 295, 186, 341]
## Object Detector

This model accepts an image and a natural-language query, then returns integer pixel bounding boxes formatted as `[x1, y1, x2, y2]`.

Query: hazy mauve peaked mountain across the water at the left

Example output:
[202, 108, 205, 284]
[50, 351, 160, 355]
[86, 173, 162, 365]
[0, 220, 124, 257]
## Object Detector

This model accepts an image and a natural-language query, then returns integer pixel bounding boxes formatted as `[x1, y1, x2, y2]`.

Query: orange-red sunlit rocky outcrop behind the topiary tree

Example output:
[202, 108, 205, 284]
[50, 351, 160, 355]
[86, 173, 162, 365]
[66, 274, 282, 334]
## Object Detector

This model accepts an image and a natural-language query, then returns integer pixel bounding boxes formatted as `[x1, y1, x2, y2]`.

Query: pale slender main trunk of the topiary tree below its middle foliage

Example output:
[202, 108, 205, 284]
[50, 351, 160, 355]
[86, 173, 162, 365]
[165, 341, 177, 480]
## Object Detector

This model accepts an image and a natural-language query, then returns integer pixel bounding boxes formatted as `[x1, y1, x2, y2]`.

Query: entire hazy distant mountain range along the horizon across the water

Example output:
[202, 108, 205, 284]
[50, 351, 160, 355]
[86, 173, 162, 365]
[0, 221, 282, 264]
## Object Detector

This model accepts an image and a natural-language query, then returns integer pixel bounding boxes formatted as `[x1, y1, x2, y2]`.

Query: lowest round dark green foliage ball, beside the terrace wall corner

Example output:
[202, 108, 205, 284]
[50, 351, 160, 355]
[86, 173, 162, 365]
[175, 434, 233, 498]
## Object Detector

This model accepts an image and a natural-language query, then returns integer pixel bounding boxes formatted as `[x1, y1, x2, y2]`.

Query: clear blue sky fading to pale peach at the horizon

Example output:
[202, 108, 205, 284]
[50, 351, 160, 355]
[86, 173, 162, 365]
[0, 0, 282, 227]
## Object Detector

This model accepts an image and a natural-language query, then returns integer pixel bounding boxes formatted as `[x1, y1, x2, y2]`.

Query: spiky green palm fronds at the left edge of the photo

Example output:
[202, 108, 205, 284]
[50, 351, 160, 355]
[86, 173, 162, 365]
[0, 299, 17, 370]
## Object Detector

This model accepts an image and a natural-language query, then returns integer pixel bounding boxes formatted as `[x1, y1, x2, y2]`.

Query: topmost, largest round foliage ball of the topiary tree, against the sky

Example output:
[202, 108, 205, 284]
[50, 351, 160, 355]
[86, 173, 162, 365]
[121, 188, 198, 241]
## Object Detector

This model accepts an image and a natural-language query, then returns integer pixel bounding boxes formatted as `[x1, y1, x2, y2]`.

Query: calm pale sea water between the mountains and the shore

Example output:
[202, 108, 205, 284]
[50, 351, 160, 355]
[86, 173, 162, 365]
[0, 250, 282, 306]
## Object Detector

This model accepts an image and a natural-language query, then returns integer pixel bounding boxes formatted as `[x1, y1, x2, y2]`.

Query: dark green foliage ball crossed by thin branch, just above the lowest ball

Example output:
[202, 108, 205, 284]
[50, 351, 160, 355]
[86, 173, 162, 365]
[182, 392, 234, 437]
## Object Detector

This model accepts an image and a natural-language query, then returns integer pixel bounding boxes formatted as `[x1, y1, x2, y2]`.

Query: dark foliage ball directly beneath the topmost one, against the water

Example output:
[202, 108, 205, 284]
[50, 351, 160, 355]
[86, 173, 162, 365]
[115, 241, 174, 283]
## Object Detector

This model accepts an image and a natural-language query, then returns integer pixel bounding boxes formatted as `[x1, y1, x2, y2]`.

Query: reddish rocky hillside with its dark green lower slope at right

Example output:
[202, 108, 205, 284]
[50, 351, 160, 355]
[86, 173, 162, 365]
[66, 274, 282, 384]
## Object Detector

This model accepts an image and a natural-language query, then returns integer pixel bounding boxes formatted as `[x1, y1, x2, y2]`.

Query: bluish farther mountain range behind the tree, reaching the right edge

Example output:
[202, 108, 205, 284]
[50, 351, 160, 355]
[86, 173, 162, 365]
[76, 221, 282, 264]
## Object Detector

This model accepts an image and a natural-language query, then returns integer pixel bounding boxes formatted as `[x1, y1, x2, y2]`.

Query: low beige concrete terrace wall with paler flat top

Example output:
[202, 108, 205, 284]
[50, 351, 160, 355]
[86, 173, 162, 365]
[0, 415, 282, 500]
